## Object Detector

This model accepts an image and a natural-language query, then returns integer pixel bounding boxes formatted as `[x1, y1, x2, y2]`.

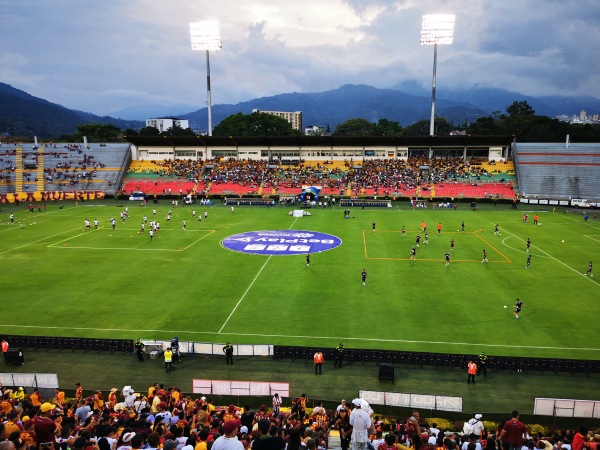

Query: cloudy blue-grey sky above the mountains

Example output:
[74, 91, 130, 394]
[0, 0, 600, 115]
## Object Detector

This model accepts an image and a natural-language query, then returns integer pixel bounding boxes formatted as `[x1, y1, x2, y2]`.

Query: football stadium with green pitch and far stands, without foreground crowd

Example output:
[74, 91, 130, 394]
[0, 136, 600, 428]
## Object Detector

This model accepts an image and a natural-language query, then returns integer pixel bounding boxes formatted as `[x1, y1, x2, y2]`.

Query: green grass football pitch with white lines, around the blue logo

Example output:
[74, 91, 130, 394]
[0, 200, 600, 359]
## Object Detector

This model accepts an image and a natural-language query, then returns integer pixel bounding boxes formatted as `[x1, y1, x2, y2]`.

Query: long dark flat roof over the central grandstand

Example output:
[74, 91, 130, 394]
[125, 135, 514, 147]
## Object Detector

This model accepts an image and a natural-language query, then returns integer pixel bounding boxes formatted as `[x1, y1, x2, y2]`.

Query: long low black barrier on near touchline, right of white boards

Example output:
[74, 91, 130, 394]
[273, 345, 600, 375]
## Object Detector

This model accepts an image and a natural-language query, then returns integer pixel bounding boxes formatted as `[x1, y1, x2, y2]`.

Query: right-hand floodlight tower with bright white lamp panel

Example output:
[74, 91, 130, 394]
[421, 14, 455, 136]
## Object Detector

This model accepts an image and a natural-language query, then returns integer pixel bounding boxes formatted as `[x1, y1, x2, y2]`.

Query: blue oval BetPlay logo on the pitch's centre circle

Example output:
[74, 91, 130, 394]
[221, 230, 342, 255]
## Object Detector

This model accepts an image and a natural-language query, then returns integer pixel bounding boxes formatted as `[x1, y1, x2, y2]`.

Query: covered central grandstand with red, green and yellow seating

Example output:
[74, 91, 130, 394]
[123, 136, 515, 198]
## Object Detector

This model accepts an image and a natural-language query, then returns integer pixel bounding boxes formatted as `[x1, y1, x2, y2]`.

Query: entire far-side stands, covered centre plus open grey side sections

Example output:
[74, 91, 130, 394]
[0, 136, 600, 201]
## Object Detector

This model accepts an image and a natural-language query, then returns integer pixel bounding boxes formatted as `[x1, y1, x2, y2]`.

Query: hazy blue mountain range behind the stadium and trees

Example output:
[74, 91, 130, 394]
[0, 83, 600, 137]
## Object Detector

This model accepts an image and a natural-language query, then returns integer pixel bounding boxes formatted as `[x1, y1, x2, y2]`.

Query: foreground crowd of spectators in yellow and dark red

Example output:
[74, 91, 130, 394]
[0, 383, 600, 450]
